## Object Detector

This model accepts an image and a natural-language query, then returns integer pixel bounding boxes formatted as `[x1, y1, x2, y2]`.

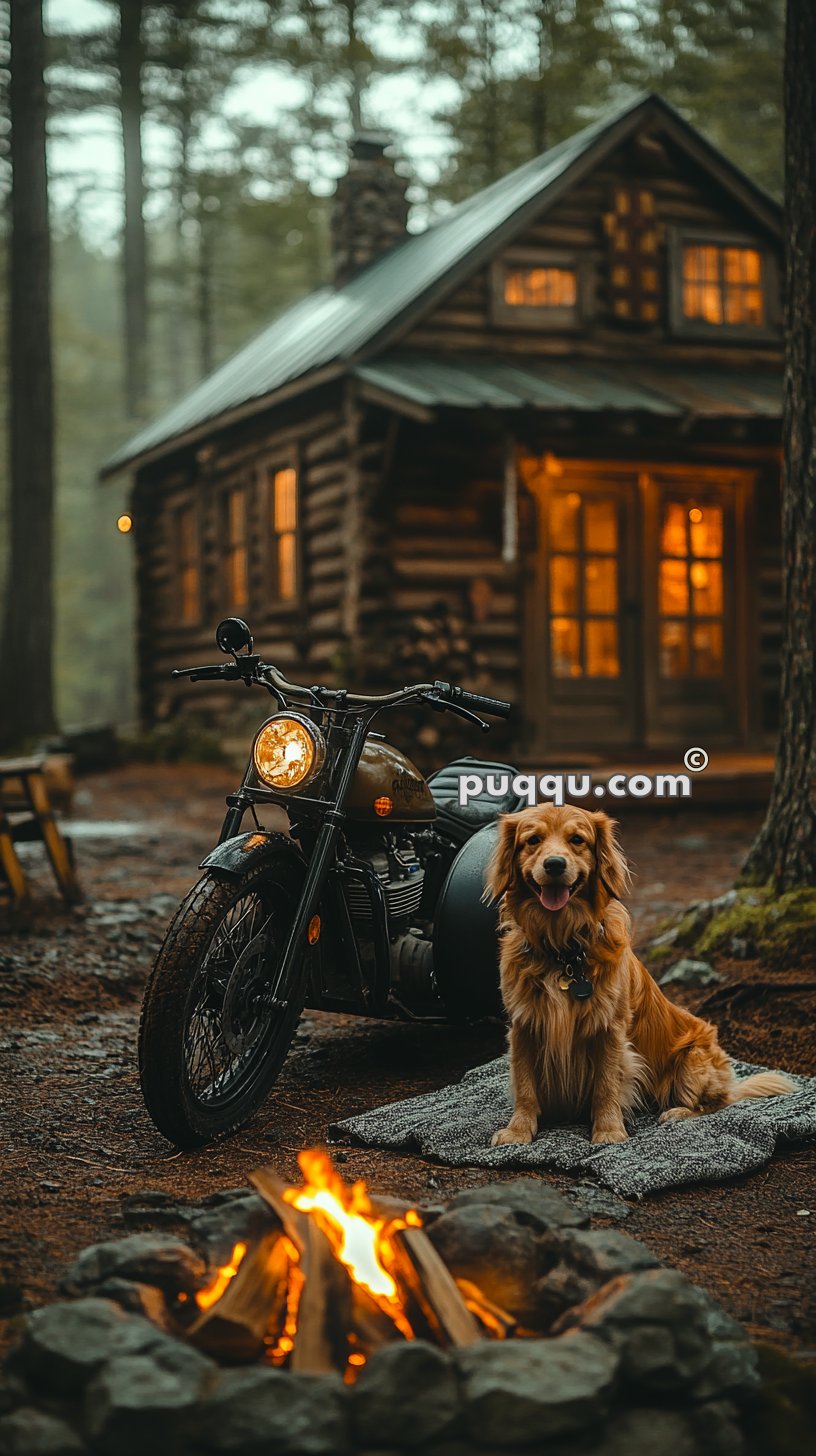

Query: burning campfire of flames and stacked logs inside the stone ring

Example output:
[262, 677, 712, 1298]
[184, 1149, 516, 1383]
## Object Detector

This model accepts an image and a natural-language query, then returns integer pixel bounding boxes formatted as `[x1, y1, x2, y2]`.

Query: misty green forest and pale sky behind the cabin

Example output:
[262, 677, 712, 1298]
[0, 0, 784, 725]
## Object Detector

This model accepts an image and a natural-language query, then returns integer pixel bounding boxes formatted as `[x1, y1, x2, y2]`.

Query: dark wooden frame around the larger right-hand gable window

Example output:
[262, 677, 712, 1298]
[667, 227, 781, 344]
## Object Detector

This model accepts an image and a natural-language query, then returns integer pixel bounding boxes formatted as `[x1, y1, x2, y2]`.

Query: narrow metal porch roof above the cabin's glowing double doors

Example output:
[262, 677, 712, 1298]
[354, 351, 782, 419]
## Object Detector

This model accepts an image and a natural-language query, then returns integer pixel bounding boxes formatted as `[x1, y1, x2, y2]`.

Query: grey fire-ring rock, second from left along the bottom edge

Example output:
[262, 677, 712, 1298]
[85, 1340, 216, 1456]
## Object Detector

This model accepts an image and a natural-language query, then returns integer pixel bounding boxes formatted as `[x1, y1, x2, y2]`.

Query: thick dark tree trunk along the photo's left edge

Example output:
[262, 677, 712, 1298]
[0, 0, 54, 745]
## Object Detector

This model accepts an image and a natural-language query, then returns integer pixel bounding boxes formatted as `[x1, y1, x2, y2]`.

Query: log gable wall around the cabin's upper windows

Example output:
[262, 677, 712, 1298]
[399, 130, 780, 364]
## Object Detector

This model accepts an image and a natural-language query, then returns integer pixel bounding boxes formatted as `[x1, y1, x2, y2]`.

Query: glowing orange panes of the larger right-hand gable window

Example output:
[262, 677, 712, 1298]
[683, 243, 765, 328]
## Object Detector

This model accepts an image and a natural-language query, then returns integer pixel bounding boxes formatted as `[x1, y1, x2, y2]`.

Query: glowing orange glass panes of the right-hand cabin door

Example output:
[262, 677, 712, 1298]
[657, 501, 724, 677]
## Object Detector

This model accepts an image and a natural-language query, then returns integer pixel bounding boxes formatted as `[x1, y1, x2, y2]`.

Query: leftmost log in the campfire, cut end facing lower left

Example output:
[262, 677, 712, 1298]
[188, 1229, 291, 1364]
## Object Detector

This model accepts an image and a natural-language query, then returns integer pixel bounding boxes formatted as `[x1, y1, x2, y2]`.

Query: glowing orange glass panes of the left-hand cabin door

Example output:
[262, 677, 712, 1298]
[549, 491, 621, 678]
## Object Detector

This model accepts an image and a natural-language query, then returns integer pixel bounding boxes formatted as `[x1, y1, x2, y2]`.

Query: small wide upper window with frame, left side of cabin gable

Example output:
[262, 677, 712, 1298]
[493, 249, 584, 329]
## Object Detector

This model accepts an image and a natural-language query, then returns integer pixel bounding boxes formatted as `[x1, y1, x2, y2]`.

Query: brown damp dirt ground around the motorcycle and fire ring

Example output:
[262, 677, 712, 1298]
[0, 764, 816, 1356]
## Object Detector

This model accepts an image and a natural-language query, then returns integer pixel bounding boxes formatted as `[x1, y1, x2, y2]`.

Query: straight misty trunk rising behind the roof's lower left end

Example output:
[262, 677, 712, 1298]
[118, 0, 147, 418]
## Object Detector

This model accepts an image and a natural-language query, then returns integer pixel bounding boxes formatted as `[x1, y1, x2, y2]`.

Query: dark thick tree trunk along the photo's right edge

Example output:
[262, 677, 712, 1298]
[743, 0, 816, 890]
